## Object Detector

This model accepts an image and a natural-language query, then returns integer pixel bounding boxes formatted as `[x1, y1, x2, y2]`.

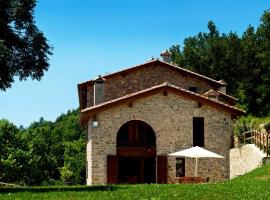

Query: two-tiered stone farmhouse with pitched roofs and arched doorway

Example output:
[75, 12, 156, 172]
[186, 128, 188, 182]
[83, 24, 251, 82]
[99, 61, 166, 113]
[78, 51, 244, 185]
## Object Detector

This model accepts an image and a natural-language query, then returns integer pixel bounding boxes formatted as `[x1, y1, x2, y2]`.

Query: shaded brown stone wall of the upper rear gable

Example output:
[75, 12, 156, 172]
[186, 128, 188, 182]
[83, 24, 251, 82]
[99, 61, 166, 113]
[87, 63, 212, 107]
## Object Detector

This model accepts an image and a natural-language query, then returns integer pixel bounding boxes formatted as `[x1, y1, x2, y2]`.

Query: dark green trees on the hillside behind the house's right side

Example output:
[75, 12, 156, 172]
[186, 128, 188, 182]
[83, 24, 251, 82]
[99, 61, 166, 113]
[170, 10, 270, 116]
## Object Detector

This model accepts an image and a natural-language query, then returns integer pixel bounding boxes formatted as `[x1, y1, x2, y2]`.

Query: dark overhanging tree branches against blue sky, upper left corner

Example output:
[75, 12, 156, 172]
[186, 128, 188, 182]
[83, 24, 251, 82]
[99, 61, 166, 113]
[0, 0, 52, 91]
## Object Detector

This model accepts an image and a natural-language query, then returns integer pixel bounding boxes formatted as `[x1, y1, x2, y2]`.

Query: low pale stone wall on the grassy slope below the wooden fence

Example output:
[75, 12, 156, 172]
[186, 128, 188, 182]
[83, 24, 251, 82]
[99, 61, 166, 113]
[230, 144, 266, 179]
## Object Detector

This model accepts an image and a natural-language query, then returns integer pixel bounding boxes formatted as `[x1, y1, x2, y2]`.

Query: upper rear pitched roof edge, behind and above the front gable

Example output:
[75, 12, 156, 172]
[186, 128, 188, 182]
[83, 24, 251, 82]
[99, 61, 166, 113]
[78, 59, 226, 87]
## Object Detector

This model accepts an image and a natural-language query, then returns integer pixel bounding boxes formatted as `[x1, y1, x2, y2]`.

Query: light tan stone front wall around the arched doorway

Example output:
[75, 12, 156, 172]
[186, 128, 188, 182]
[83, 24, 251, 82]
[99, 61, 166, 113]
[87, 90, 231, 184]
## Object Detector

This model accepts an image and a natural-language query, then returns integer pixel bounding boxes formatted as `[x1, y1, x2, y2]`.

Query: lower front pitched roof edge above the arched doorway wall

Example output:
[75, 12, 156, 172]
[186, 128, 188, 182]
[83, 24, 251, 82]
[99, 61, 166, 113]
[80, 82, 245, 124]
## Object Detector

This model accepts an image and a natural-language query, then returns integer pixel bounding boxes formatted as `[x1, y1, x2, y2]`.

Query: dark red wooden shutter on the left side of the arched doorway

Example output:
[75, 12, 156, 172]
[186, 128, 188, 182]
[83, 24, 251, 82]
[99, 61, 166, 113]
[107, 155, 118, 184]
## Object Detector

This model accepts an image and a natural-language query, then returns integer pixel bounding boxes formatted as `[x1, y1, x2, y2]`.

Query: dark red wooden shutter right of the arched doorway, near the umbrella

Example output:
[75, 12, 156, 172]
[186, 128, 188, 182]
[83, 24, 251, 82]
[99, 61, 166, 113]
[157, 156, 168, 183]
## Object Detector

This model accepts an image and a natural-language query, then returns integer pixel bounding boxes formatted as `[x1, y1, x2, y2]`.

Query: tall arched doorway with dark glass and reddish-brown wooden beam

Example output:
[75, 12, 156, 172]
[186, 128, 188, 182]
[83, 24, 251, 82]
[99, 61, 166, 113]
[117, 120, 156, 184]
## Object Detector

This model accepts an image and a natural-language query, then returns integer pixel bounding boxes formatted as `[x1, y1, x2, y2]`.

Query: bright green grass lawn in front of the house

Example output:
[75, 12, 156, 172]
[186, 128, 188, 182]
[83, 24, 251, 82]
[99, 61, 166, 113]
[0, 164, 270, 200]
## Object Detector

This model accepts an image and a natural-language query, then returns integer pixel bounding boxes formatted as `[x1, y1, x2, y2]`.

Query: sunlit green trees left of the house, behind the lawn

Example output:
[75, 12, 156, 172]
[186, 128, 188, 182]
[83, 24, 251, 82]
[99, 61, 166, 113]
[0, 110, 86, 185]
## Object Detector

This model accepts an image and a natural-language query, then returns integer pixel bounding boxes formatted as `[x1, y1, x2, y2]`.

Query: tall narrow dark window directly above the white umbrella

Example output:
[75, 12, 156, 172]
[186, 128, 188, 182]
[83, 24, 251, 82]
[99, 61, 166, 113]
[193, 117, 204, 147]
